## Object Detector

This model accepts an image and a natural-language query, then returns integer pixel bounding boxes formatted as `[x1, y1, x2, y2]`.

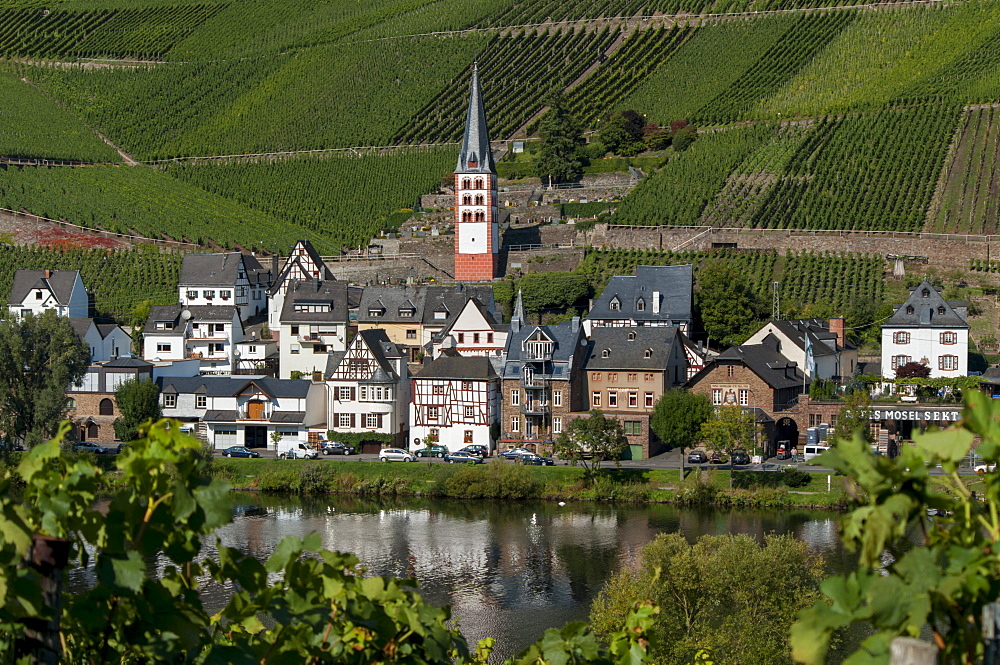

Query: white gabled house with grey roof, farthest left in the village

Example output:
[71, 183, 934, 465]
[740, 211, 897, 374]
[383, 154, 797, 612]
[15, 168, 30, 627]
[7, 270, 92, 319]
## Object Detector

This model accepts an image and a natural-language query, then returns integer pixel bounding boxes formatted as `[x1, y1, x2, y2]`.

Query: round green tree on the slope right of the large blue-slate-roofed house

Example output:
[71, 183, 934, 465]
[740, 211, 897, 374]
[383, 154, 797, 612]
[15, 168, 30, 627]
[696, 260, 763, 344]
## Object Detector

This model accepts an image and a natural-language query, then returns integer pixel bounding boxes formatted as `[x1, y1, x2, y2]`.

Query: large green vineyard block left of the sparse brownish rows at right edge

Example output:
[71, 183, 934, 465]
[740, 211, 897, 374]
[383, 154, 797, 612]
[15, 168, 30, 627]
[753, 105, 959, 231]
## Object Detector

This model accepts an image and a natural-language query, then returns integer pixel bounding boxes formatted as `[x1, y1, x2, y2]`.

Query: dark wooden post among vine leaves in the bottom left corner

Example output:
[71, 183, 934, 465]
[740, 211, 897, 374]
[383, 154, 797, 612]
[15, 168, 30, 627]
[14, 534, 71, 665]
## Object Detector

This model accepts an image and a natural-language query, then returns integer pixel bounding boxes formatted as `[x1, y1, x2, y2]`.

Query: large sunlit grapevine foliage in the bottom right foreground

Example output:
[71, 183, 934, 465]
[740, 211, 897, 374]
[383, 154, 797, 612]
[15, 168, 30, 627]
[791, 391, 1000, 665]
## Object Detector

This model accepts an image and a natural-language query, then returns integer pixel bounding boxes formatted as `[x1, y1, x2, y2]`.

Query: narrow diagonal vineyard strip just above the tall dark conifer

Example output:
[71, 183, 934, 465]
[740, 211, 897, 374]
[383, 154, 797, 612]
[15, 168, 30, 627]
[570, 25, 695, 127]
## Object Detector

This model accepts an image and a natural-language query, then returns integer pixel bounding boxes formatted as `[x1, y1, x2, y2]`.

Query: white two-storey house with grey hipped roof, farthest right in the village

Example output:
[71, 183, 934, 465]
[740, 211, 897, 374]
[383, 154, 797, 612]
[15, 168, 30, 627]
[882, 282, 969, 378]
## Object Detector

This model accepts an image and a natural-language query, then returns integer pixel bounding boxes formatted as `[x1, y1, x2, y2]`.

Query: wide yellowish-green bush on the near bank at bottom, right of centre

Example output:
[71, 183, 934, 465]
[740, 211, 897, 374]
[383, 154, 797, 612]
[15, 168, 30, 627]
[590, 533, 823, 665]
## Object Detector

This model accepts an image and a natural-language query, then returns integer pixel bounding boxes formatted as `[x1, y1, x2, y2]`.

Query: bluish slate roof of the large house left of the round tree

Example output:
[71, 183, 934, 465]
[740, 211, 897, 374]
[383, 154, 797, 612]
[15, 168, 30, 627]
[587, 264, 694, 321]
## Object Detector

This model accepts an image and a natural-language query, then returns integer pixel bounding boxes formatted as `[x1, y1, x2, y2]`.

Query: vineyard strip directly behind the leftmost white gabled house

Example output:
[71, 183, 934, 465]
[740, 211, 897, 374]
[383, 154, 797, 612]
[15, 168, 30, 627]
[0, 245, 182, 317]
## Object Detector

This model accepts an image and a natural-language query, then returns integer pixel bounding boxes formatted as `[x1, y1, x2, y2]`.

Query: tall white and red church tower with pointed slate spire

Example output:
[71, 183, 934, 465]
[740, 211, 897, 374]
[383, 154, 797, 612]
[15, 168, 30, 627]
[455, 66, 500, 281]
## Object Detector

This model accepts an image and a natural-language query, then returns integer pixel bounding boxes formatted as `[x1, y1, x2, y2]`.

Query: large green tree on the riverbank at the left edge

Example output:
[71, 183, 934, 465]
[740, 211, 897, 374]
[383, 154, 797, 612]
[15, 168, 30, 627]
[0, 310, 90, 447]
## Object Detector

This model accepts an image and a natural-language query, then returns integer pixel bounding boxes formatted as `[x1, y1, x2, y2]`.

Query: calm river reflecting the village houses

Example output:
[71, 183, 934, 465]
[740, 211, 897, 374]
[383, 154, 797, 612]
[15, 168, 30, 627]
[206, 493, 854, 660]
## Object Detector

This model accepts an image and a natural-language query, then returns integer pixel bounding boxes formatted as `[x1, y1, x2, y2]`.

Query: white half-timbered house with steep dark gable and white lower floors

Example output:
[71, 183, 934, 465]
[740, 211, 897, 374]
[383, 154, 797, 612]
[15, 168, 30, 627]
[326, 330, 410, 452]
